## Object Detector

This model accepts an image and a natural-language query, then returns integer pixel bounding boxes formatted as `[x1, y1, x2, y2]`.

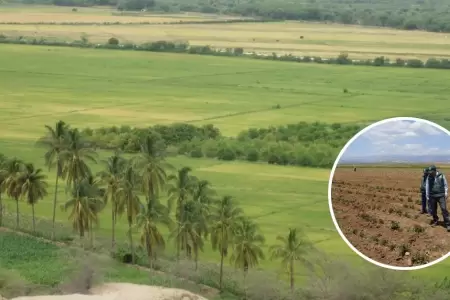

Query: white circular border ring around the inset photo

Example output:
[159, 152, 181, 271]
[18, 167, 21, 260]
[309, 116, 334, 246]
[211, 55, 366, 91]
[328, 117, 450, 271]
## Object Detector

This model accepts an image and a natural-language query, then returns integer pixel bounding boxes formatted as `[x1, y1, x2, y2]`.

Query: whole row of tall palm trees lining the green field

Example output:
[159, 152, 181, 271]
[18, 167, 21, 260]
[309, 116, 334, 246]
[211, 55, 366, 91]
[0, 121, 311, 289]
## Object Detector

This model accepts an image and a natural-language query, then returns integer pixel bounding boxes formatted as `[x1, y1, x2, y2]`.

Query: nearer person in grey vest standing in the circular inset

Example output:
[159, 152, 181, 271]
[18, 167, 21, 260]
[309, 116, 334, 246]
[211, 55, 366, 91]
[425, 166, 450, 232]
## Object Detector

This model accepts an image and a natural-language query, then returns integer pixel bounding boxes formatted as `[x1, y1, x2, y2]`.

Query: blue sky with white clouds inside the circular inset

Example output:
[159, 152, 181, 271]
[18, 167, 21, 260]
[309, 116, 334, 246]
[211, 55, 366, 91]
[341, 120, 450, 159]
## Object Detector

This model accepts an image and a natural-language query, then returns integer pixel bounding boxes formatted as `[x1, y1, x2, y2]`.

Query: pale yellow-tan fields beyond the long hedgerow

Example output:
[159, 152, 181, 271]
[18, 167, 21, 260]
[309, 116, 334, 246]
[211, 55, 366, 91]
[0, 7, 450, 60]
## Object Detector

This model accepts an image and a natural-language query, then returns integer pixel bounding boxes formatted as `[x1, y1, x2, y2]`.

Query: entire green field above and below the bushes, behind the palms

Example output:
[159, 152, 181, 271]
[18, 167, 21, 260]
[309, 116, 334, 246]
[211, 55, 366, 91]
[0, 45, 450, 284]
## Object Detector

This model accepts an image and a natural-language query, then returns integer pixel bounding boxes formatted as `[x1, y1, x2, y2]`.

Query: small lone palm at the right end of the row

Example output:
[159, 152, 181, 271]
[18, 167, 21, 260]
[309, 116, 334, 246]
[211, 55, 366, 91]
[270, 229, 313, 292]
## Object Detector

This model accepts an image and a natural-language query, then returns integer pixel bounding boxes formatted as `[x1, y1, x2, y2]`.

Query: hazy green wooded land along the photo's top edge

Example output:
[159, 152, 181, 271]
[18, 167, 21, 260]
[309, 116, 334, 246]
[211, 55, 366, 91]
[6, 0, 450, 32]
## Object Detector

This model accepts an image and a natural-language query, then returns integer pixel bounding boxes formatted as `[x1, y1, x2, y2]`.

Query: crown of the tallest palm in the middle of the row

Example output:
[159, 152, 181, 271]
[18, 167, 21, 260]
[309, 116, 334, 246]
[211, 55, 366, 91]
[133, 136, 172, 201]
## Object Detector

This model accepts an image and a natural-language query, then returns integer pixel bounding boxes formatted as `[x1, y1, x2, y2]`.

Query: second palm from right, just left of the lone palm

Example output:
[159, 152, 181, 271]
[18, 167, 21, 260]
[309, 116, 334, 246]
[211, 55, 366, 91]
[230, 218, 265, 276]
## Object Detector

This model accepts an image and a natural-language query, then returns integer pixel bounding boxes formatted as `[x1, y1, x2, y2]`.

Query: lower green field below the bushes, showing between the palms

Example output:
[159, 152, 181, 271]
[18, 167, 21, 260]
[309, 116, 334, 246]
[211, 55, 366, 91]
[0, 141, 336, 274]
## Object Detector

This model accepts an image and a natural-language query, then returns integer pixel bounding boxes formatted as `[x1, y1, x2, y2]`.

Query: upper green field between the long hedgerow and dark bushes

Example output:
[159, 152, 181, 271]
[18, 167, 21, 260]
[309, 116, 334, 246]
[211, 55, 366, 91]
[0, 45, 450, 139]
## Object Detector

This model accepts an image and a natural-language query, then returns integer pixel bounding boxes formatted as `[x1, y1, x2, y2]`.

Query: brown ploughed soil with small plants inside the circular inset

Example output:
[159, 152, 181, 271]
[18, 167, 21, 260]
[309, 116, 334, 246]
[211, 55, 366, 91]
[331, 168, 450, 267]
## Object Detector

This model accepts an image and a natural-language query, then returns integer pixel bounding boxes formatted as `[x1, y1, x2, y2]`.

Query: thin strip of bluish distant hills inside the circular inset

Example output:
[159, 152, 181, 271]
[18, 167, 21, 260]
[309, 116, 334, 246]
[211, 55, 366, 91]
[339, 154, 450, 164]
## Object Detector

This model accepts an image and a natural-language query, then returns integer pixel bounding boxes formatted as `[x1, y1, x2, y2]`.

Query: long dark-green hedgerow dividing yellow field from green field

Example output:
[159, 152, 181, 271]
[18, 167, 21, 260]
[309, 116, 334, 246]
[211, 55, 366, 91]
[0, 33, 450, 69]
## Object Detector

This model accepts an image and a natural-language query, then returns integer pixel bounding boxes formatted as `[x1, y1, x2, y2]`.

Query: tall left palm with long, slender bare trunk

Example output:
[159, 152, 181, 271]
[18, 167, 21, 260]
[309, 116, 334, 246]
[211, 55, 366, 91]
[38, 121, 69, 240]
